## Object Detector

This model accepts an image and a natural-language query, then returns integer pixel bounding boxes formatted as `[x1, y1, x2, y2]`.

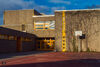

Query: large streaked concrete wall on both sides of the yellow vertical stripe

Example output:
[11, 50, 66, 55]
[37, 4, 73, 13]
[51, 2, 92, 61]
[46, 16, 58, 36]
[55, 10, 100, 52]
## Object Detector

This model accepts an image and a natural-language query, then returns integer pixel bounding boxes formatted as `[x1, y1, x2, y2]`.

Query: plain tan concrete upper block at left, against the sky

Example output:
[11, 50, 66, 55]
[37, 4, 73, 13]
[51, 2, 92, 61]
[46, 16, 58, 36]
[4, 10, 41, 25]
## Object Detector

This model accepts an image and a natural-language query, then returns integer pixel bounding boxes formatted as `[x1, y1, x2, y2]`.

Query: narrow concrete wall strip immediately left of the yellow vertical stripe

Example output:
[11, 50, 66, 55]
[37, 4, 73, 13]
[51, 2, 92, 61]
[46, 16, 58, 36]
[55, 12, 62, 51]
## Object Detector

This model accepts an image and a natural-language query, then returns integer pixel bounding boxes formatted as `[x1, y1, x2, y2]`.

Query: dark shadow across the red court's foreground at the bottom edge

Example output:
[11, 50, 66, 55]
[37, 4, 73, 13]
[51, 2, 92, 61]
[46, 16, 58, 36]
[0, 59, 100, 67]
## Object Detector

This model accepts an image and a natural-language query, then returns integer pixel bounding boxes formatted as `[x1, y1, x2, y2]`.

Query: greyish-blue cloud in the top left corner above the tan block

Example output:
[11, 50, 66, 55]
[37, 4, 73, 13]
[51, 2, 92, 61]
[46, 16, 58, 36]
[0, 0, 33, 10]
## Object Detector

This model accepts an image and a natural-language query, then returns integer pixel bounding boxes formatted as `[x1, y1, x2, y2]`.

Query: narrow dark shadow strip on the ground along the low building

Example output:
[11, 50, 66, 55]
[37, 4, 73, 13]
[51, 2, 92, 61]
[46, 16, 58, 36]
[0, 50, 53, 60]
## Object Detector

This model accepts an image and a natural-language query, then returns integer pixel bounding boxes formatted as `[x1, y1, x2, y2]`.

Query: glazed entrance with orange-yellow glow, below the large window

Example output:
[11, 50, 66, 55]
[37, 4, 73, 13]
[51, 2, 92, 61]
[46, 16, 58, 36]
[36, 38, 55, 50]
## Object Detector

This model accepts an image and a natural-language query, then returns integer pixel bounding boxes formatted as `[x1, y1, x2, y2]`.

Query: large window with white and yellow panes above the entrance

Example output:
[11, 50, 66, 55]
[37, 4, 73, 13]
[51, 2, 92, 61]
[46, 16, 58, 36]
[34, 21, 55, 30]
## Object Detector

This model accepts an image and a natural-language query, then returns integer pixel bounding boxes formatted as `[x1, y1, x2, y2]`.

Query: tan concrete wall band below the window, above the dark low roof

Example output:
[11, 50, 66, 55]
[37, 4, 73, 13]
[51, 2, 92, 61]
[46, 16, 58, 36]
[2, 23, 55, 37]
